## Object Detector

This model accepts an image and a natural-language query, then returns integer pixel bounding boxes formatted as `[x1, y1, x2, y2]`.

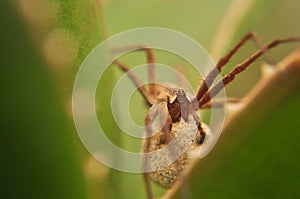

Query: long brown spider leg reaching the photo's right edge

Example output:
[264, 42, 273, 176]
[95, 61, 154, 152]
[198, 37, 300, 108]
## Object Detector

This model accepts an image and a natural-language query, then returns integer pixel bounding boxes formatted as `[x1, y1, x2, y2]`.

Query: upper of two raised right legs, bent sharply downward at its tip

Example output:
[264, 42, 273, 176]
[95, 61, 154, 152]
[196, 32, 270, 101]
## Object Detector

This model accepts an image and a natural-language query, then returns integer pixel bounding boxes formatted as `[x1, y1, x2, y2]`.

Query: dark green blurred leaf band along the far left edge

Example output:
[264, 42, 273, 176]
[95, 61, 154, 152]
[0, 1, 86, 199]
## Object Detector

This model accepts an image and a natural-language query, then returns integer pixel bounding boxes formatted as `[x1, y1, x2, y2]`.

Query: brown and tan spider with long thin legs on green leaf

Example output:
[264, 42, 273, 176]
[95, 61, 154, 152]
[114, 32, 300, 199]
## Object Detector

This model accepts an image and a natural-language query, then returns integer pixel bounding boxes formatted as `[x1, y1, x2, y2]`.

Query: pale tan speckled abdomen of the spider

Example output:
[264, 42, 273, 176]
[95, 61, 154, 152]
[143, 103, 201, 189]
